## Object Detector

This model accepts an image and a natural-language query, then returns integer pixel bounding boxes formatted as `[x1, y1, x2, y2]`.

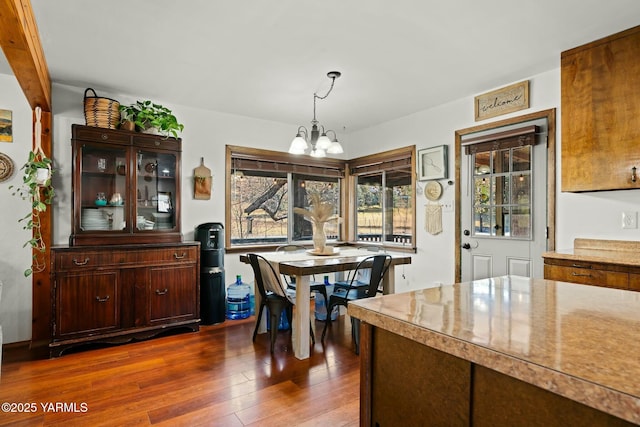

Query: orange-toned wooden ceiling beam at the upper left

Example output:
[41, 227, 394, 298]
[0, 0, 51, 112]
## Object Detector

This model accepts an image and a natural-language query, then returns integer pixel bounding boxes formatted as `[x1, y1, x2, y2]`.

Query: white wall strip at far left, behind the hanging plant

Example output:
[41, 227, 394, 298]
[0, 74, 32, 343]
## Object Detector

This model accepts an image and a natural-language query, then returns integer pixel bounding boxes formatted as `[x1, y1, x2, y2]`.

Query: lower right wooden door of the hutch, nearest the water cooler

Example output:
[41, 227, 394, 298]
[148, 264, 198, 325]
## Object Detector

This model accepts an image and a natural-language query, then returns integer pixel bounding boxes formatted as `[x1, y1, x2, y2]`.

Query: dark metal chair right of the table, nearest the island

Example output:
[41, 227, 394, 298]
[321, 254, 391, 354]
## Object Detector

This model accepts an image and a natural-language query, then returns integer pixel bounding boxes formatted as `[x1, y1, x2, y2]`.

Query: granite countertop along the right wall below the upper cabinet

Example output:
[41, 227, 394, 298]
[542, 239, 640, 267]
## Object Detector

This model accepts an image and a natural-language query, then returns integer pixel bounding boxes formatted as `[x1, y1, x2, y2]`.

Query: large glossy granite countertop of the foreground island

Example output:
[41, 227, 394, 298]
[349, 276, 640, 423]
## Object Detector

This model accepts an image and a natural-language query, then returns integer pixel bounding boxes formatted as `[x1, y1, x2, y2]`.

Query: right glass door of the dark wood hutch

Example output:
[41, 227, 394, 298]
[135, 151, 177, 232]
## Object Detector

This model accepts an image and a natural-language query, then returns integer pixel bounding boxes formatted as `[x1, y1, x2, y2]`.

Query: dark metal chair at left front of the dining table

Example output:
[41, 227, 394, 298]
[248, 254, 316, 353]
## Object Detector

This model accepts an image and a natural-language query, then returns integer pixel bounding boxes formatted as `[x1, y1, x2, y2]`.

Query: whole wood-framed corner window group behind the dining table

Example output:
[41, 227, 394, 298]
[226, 146, 415, 249]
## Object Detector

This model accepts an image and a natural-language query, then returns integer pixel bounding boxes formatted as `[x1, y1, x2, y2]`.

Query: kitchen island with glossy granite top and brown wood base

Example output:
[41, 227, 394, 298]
[349, 276, 640, 426]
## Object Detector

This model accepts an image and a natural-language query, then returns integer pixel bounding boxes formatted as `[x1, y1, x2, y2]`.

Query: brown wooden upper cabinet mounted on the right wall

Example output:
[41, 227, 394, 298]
[561, 26, 640, 192]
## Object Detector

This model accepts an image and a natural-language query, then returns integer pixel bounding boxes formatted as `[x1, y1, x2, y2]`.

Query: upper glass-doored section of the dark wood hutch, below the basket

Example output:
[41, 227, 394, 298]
[69, 125, 182, 245]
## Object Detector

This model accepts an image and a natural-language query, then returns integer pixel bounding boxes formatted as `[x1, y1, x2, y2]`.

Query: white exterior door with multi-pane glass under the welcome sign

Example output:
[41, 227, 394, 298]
[459, 119, 548, 281]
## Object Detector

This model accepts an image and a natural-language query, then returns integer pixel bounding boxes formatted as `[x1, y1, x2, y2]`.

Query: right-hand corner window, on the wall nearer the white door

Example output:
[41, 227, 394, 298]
[349, 147, 415, 247]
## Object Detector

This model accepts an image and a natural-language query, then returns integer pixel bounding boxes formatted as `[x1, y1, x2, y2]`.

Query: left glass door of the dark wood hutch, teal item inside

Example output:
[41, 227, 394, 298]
[76, 144, 129, 232]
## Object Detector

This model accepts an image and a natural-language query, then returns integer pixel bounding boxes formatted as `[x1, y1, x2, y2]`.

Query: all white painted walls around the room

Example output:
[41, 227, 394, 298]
[0, 68, 640, 342]
